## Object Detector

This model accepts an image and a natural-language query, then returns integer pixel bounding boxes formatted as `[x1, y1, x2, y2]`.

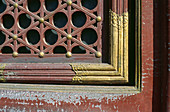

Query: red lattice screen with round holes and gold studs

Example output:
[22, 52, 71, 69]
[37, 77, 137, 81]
[0, 0, 103, 62]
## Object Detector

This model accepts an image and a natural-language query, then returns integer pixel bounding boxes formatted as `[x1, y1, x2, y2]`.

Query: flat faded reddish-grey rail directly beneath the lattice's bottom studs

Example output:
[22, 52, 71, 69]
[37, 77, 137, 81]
[0, 54, 102, 64]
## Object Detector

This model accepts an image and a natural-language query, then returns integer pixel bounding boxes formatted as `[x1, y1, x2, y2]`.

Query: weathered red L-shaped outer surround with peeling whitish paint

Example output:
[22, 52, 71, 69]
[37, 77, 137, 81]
[0, 0, 154, 112]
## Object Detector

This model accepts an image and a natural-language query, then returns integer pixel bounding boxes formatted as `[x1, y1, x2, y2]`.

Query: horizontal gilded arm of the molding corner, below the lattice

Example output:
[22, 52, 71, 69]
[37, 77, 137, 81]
[70, 63, 120, 83]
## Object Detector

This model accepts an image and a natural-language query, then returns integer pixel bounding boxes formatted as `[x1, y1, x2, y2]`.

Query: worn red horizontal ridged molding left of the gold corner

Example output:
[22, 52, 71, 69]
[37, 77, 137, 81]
[0, 63, 75, 83]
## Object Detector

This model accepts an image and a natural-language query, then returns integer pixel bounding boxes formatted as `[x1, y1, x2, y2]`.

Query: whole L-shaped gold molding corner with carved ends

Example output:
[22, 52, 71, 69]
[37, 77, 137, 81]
[70, 10, 129, 84]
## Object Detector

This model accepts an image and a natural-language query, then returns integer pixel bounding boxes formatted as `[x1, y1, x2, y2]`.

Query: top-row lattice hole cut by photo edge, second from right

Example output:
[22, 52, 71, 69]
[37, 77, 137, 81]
[45, 0, 58, 11]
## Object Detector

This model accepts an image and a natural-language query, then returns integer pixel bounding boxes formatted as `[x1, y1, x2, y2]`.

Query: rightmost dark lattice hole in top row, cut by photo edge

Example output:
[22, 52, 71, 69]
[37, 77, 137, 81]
[81, 0, 98, 10]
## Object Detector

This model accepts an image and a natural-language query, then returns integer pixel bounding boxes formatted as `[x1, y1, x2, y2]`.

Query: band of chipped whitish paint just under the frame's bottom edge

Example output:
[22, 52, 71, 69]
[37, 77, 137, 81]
[0, 90, 135, 111]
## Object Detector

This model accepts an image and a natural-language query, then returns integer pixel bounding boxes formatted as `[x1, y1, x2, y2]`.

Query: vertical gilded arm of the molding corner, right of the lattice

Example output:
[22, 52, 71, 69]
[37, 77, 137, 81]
[110, 10, 129, 78]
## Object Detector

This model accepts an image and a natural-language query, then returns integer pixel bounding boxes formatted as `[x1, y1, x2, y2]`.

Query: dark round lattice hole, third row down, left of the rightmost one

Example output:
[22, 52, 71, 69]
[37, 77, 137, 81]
[45, 29, 58, 45]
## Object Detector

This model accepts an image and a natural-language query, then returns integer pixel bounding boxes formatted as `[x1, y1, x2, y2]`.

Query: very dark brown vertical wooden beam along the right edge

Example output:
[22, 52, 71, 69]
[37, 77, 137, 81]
[153, 0, 170, 112]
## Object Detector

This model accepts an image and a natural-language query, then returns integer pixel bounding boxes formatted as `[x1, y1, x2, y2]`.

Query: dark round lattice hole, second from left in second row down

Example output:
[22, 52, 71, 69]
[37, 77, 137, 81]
[19, 14, 31, 29]
